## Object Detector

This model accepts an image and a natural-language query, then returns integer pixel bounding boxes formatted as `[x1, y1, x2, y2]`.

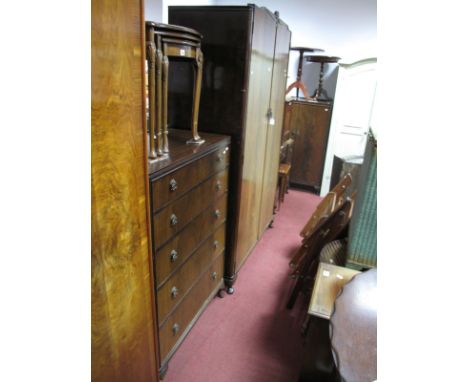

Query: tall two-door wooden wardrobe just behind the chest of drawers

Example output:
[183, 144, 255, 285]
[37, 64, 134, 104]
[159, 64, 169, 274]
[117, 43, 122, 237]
[169, 4, 291, 293]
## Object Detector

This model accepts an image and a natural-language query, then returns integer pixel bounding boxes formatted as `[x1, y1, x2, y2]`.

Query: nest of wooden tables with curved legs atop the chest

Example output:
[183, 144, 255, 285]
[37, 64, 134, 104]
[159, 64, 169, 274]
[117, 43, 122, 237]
[146, 21, 204, 159]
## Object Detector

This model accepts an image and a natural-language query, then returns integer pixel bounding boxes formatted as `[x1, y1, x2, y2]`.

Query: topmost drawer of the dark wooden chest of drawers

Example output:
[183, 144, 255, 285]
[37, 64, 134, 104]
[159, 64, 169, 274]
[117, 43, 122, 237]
[152, 146, 229, 212]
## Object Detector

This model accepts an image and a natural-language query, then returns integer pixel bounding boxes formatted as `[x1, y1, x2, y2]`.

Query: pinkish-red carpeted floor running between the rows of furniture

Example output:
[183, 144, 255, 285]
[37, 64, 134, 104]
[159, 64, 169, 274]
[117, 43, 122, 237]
[164, 190, 320, 382]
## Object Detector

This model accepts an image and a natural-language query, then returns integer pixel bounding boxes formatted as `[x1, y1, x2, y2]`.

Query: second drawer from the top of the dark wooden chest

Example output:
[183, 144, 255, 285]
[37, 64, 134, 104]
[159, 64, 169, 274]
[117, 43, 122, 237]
[153, 190, 227, 248]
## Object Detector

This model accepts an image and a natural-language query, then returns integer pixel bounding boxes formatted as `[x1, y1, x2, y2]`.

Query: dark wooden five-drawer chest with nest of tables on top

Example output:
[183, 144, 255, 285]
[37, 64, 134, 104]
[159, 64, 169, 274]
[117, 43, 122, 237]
[149, 130, 230, 376]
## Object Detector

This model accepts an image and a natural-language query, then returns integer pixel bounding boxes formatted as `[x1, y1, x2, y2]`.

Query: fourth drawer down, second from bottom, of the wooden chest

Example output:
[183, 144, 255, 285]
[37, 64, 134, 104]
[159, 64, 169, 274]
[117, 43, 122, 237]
[158, 224, 225, 325]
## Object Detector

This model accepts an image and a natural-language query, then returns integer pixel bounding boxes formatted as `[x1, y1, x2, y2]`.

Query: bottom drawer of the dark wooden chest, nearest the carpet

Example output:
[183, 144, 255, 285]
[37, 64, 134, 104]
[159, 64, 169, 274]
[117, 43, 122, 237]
[159, 255, 224, 363]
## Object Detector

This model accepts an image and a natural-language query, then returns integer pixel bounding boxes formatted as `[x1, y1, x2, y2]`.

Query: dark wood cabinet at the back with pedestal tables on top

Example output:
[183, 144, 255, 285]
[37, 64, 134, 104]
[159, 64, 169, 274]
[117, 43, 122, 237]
[285, 100, 332, 193]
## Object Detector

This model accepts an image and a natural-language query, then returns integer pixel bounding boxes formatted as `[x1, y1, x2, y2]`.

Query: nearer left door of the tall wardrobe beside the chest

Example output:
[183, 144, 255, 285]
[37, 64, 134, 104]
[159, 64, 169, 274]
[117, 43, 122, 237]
[235, 8, 276, 270]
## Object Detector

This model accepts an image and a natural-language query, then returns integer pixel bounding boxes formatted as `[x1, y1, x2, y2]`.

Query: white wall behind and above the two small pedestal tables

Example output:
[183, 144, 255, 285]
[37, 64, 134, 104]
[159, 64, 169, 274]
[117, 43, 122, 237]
[214, 0, 377, 96]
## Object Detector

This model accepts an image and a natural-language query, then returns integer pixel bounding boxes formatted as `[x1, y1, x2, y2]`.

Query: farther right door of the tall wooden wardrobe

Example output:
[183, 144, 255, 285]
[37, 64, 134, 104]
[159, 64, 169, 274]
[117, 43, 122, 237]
[258, 21, 291, 234]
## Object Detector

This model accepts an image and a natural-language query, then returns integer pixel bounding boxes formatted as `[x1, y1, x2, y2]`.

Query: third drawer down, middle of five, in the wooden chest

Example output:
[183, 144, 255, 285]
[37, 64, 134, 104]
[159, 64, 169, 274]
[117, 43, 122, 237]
[155, 197, 227, 288]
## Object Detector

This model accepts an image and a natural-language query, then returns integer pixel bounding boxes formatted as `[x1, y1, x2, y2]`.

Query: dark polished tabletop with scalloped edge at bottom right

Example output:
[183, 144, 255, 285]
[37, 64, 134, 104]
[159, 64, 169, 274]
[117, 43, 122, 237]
[330, 269, 377, 382]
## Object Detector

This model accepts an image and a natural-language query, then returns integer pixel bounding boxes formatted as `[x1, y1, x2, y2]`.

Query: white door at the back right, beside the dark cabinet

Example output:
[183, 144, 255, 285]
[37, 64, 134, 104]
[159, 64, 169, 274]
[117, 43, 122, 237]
[320, 58, 377, 196]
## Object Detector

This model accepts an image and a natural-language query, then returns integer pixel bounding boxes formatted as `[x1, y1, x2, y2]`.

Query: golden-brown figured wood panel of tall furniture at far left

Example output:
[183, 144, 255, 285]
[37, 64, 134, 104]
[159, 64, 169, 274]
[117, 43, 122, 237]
[91, 0, 157, 382]
